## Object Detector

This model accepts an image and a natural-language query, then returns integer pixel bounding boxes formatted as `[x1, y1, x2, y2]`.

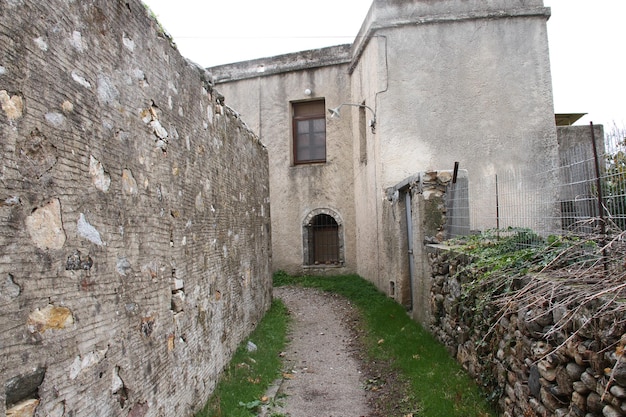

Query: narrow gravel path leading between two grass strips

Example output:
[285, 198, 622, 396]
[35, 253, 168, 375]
[265, 287, 370, 417]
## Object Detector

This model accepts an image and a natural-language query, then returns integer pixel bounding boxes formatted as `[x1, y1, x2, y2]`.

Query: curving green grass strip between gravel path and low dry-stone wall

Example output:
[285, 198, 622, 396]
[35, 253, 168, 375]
[274, 272, 496, 417]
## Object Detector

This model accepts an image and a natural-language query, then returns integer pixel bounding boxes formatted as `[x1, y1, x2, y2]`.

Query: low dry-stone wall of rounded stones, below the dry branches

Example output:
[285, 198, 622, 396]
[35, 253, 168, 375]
[429, 246, 626, 417]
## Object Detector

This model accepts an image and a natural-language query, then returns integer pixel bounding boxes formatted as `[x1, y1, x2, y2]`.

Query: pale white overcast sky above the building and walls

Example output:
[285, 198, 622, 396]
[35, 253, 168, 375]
[143, 0, 626, 130]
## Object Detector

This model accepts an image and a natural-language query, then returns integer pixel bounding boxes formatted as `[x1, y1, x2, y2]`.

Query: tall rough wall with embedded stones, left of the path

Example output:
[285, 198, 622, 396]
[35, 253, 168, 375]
[0, 0, 271, 417]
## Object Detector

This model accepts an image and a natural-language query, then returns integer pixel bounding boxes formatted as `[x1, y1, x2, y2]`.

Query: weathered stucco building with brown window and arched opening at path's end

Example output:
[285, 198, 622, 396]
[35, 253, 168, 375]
[209, 0, 557, 300]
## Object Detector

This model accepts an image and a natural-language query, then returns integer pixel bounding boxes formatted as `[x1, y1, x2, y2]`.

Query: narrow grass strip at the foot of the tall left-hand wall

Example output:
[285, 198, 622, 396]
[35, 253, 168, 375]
[196, 300, 290, 417]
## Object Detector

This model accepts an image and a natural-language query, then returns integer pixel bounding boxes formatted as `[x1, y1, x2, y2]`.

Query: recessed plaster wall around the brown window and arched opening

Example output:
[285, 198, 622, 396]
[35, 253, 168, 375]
[210, 54, 356, 274]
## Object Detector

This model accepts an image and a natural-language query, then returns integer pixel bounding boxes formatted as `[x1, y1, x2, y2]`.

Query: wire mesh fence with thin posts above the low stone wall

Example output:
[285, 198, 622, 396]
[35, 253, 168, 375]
[446, 126, 626, 238]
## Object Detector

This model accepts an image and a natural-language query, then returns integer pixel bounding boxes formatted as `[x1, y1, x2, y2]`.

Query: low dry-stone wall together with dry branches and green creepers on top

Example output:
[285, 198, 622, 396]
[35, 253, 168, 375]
[431, 229, 626, 415]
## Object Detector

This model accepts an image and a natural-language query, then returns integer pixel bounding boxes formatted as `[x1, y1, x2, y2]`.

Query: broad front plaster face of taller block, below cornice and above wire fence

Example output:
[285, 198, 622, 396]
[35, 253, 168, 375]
[372, 12, 557, 186]
